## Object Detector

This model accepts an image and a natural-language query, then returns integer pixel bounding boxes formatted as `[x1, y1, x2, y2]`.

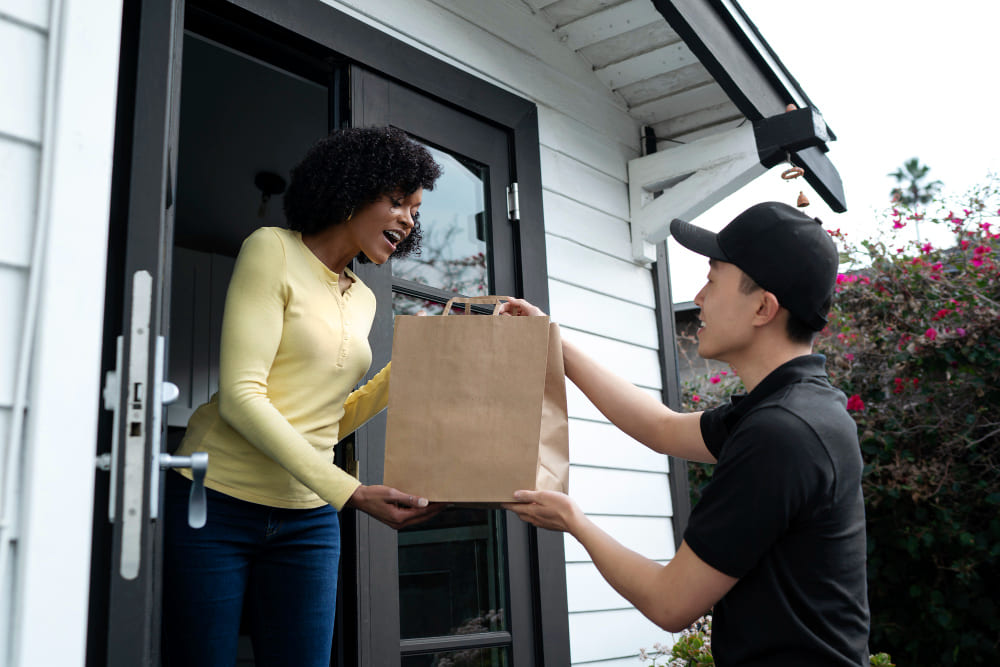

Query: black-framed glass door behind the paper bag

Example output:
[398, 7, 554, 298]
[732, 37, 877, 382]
[351, 69, 534, 667]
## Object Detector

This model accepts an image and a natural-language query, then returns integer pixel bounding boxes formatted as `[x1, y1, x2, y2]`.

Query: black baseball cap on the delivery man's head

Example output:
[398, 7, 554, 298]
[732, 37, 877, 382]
[670, 202, 840, 331]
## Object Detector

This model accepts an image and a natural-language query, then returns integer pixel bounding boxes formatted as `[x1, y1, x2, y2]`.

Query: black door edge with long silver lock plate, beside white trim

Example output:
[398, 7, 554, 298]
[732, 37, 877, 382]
[93, 0, 184, 666]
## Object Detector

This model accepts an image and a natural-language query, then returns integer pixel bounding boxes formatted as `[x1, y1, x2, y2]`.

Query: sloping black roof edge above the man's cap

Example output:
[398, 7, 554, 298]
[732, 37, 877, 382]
[653, 0, 847, 213]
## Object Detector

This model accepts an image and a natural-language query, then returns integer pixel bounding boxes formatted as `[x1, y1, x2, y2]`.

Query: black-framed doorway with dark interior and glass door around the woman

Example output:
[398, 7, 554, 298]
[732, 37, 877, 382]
[91, 0, 566, 667]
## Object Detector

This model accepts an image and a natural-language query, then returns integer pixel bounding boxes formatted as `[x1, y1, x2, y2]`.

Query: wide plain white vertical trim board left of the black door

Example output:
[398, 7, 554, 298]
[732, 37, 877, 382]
[14, 0, 122, 667]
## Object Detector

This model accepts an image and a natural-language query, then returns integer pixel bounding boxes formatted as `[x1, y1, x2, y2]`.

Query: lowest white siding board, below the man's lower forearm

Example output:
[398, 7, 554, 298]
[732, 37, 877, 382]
[569, 609, 673, 665]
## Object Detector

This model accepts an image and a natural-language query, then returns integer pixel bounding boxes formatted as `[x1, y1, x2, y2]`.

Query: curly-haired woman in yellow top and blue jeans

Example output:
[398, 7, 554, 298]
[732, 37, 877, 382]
[163, 128, 440, 667]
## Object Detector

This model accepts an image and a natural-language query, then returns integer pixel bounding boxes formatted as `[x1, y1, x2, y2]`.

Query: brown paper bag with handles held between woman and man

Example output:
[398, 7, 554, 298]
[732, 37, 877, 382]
[383, 296, 569, 504]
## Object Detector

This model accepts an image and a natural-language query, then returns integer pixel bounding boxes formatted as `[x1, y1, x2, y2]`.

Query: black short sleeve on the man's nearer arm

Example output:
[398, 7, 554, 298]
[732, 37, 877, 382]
[684, 407, 833, 578]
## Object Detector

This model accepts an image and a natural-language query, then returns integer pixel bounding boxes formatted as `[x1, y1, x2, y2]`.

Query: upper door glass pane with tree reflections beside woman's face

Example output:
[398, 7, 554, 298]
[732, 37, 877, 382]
[392, 146, 490, 306]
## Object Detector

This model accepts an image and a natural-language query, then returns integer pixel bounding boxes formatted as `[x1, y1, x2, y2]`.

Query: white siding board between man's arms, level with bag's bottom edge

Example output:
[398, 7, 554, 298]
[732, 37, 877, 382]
[569, 465, 673, 516]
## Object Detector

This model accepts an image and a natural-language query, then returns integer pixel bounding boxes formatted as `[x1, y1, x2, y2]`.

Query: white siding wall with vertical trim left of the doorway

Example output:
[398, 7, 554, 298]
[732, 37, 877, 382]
[0, 0, 121, 667]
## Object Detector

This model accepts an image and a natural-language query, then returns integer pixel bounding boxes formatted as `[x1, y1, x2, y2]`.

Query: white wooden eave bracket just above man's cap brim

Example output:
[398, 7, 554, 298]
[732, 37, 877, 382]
[628, 123, 767, 264]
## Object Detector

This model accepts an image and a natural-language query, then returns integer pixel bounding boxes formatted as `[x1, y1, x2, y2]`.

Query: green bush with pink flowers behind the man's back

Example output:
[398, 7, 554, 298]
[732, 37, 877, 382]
[685, 177, 1000, 665]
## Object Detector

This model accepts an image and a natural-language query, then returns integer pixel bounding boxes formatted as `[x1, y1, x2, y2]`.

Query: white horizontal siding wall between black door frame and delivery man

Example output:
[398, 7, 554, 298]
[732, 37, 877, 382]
[328, 0, 674, 665]
